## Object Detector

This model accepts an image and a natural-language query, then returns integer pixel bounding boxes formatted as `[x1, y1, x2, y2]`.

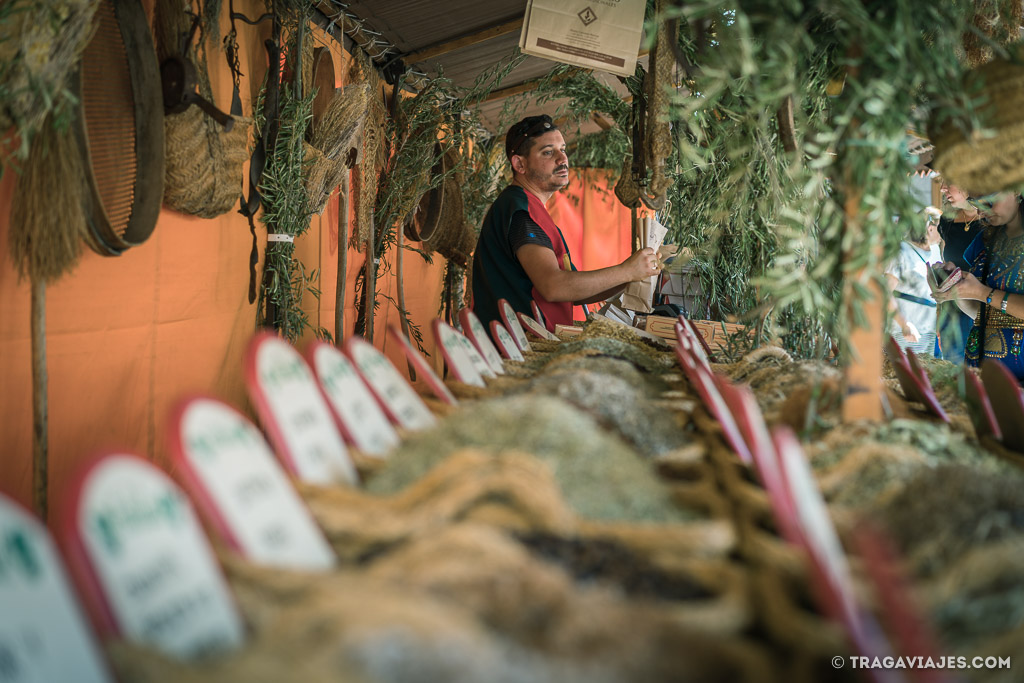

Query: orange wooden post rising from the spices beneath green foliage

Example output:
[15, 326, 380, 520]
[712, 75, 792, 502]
[843, 182, 886, 422]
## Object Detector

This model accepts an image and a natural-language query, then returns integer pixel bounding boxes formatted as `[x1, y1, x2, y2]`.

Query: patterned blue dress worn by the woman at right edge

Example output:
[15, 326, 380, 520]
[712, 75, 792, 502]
[964, 227, 1024, 380]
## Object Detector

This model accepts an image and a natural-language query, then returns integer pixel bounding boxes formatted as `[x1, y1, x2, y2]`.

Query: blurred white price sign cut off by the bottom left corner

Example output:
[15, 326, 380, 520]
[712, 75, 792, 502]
[0, 495, 114, 683]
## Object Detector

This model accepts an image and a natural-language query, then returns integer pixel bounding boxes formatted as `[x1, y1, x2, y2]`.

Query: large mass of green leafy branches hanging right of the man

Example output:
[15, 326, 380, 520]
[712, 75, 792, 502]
[665, 0, 972, 355]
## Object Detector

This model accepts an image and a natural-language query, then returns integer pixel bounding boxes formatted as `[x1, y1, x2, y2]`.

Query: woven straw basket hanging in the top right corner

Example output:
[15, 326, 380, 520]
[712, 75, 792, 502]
[929, 47, 1024, 195]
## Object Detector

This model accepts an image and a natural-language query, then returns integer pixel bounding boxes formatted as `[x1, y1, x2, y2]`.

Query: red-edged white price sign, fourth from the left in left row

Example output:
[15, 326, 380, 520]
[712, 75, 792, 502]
[246, 333, 359, 484]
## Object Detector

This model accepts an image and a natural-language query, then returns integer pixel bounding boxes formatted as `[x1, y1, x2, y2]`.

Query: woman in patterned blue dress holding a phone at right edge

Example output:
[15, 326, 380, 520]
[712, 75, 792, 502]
[936, 193, 1024, 381]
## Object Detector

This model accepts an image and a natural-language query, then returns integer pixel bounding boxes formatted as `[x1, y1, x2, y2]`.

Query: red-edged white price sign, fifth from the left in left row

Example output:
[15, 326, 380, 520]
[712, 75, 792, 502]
[309, 342, 398, 457]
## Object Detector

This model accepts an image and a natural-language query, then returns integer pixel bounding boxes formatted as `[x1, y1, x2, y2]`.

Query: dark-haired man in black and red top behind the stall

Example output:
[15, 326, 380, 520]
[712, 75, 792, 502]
[473, 115, 659, 331]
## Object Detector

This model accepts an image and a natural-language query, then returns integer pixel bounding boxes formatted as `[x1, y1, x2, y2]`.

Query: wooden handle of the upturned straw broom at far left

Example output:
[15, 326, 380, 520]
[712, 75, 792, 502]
[31, 276, 49, 523]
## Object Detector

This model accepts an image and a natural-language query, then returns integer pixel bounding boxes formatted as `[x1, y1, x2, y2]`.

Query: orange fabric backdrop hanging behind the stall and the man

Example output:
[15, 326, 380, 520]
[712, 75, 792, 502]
[0, 0, 629, 511]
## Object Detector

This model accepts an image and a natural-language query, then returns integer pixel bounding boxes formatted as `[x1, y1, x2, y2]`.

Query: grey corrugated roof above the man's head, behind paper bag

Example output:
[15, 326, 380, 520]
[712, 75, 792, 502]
[319, 0, 626, 139]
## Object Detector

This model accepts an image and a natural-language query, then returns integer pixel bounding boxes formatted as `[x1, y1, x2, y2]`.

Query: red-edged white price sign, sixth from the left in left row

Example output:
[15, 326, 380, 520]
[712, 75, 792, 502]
[345, 337, 437, 429]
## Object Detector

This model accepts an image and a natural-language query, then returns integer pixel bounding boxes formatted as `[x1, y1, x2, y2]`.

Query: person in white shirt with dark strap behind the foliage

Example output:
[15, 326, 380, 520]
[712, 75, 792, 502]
[885, 207, 942, 355]
